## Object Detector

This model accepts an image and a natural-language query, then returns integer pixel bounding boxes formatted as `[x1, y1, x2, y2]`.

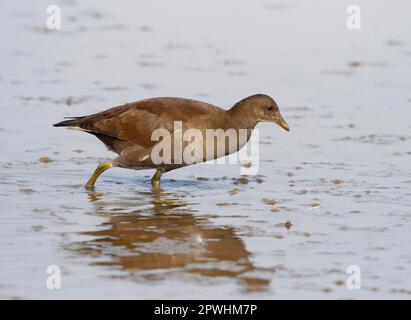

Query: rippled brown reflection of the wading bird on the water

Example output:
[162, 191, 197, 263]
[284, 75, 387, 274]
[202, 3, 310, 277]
[73, 192, 270, 291]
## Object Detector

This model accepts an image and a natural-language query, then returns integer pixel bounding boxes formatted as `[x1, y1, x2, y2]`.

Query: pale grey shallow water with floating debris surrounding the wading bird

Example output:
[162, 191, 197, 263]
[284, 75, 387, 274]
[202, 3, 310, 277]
[0, 0, 411, 299]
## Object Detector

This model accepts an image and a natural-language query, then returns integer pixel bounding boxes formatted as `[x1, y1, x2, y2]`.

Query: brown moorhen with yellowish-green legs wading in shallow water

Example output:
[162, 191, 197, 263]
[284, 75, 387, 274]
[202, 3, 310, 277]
[54, 94, 289, 189]
